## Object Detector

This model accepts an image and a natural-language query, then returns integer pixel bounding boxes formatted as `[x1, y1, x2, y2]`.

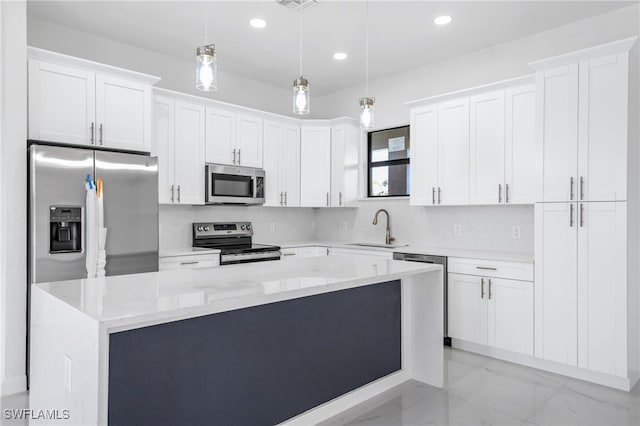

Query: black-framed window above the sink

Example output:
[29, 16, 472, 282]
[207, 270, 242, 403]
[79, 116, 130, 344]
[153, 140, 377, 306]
[367, 126, 411, 197]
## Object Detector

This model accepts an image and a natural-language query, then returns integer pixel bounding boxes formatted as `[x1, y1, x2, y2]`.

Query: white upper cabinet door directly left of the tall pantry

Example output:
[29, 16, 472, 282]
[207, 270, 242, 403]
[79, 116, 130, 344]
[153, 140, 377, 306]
[504, 85, 536, 204]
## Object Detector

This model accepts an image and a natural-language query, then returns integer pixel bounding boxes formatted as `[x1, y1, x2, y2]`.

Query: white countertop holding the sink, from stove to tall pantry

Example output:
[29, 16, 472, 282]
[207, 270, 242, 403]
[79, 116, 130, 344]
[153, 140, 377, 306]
[266, 241, 533, 263]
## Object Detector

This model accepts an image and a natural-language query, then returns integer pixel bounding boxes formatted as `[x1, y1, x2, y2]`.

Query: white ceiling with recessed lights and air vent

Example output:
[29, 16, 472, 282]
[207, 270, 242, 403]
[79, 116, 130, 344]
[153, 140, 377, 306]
[28, 0, 637, 96]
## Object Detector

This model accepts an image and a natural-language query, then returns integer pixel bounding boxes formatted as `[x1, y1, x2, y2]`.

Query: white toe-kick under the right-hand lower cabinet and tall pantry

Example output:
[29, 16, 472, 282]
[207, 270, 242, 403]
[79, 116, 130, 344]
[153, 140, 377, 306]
[451, 339, 632, 392]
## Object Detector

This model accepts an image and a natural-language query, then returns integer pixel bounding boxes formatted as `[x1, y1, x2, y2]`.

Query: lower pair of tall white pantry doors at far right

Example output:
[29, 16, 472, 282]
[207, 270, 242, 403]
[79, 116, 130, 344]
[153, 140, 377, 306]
[535, 202, 627, 377]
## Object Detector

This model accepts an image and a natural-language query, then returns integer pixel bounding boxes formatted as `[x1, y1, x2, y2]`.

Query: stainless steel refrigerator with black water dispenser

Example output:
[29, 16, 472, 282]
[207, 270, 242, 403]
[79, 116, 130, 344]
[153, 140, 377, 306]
[29, 144, 158, 284]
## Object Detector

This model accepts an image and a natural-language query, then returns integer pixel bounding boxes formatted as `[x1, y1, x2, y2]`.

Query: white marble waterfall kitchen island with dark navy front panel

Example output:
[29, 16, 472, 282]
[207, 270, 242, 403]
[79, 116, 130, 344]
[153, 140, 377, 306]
[30, 256, 443, 426]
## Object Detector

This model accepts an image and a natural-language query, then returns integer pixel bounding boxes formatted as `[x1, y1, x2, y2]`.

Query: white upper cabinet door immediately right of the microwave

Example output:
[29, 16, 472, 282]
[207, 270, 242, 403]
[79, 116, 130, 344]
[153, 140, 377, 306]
[263, 120, 284, 207]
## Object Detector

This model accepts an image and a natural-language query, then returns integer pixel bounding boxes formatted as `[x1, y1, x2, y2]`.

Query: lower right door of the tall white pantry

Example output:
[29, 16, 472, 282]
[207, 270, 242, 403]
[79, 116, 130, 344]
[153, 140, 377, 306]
[578, 202, 627, 377]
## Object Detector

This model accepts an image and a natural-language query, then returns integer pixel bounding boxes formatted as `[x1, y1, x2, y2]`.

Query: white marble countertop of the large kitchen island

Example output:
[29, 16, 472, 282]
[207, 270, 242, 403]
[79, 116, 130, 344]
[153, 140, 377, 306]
[34, 256, 441, 331]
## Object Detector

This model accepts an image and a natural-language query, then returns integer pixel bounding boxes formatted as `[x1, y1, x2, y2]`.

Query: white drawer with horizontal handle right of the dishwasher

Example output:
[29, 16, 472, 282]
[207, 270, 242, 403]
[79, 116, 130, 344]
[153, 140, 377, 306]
[447, 257, 533, 281]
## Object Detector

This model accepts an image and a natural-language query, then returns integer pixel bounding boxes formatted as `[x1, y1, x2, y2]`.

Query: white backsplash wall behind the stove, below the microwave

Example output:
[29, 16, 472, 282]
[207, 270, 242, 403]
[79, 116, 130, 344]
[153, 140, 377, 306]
[160, 205, 316, 248]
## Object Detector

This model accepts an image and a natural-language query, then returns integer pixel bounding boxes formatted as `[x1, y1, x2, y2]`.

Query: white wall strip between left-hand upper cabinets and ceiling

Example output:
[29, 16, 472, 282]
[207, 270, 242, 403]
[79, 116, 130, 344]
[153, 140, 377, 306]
[27, 17, 292, 115]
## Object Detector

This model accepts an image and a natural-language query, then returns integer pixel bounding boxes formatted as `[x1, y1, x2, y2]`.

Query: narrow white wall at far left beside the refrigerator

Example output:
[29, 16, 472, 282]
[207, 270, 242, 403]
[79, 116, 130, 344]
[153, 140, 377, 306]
[0, 1, 27, 394]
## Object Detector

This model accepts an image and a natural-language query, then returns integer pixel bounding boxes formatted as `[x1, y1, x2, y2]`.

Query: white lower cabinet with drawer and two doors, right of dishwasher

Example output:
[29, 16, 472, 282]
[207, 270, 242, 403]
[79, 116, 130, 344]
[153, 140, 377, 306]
[448, 258, 534, 355]
